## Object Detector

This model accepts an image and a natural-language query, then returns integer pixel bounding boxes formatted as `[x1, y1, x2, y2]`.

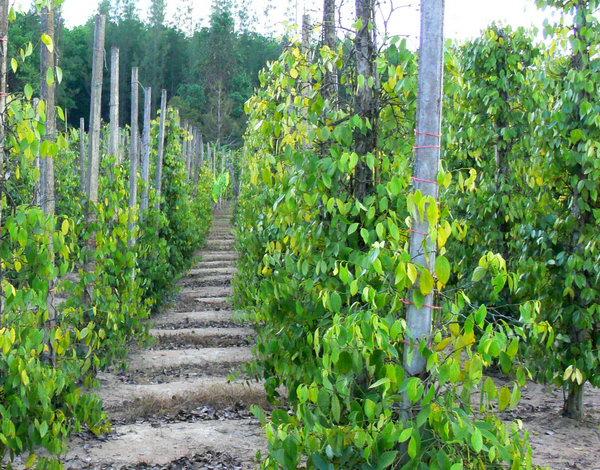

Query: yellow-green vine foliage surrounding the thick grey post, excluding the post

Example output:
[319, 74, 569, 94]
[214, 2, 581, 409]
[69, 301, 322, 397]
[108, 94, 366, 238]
[235, 35, 537, 469]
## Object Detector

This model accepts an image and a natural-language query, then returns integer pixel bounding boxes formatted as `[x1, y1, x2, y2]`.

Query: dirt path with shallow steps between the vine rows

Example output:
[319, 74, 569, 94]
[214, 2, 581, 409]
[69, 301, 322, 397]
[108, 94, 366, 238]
[65, 209, 266, 469]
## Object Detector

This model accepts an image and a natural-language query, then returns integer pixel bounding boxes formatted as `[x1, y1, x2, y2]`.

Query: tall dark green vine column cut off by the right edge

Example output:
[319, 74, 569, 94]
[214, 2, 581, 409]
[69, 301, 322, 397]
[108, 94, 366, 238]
[521, 1, 600, 412]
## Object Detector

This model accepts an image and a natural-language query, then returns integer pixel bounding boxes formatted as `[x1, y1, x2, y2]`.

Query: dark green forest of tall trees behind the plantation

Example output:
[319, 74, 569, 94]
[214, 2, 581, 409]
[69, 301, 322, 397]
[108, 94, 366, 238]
[9, 0, 283, 146]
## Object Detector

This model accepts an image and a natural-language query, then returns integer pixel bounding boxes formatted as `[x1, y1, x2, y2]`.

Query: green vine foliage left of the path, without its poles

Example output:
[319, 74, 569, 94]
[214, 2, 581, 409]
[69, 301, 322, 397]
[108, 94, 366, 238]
[0, 95, 214, 467]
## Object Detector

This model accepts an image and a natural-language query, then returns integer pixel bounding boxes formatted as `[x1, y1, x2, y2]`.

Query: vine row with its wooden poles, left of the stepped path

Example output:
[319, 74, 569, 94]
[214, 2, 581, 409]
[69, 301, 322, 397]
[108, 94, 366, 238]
[0, 0, 229, 468]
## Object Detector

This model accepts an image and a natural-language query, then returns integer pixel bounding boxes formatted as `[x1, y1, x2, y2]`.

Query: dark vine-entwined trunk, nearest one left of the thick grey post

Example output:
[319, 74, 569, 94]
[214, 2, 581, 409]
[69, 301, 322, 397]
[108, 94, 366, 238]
[354, 0, 377, 200]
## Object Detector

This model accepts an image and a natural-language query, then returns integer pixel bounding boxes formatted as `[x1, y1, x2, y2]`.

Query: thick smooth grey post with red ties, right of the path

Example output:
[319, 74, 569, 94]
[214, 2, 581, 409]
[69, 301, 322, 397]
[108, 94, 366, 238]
[404, 0, 444, 375]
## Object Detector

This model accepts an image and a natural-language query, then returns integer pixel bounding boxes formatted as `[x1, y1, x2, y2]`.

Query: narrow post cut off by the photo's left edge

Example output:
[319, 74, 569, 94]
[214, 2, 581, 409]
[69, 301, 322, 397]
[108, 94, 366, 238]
[0, 0, 9, 325]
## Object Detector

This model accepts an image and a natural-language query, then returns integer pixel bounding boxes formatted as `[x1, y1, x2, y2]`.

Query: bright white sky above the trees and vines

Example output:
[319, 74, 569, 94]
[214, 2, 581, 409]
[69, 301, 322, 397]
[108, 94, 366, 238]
[14, 0, 547, 42]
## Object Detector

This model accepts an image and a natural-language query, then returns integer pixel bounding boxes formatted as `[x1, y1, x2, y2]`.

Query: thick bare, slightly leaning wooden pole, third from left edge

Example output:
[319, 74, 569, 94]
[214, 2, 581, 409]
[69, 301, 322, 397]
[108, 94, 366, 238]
[87, 15, 106, 204]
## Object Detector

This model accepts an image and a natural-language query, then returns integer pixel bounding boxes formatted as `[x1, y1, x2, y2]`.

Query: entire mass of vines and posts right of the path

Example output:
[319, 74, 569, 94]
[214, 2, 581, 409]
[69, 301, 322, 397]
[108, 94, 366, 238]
[235, 0, 600, 470]
